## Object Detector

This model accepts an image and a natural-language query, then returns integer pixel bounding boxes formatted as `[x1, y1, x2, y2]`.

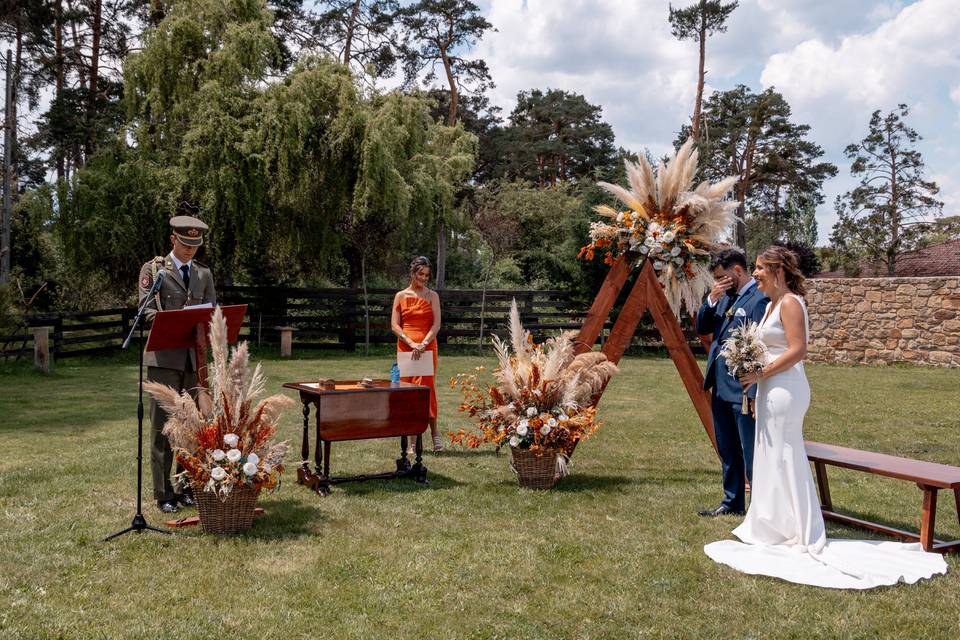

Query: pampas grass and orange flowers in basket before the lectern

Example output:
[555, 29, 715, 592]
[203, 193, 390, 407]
[144, 308, 293, 500]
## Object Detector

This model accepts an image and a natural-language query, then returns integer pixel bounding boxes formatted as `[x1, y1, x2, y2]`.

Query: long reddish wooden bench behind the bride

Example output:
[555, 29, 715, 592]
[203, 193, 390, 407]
[805, 440, 960, 553]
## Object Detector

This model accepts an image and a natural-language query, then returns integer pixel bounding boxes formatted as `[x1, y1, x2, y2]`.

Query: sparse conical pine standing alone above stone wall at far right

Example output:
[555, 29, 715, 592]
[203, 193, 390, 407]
[830, 104, 943, 276]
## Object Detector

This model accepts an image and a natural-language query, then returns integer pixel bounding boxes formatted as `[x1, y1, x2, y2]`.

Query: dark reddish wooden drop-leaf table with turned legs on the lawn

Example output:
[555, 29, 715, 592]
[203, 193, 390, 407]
[283, 380, 430, 496]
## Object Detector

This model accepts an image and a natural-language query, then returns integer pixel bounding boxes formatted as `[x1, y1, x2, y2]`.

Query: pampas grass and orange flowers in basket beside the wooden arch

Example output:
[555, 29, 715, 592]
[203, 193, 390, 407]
[449, 300, 618, 484]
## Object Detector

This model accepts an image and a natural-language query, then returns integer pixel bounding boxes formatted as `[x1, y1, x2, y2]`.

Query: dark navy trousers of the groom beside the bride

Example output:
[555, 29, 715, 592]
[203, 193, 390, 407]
[712, 394, 756, 511]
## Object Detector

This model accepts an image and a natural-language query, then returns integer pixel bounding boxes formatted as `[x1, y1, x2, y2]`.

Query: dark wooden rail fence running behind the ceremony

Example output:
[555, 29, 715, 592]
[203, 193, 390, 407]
[0, 286, 702, 360]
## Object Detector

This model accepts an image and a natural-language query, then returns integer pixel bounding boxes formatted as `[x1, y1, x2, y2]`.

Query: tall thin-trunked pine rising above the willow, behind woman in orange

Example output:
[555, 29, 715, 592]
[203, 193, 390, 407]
[397, 0, 493, 289]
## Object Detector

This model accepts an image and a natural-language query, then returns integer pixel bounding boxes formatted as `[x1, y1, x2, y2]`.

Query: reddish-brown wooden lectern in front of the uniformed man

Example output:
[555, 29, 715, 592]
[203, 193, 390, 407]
[146, 304, 247, 389]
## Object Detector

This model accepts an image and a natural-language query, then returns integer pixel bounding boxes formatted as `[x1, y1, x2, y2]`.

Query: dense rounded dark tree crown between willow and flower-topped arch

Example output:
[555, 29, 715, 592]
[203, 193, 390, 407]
[499, 89, 616, 186]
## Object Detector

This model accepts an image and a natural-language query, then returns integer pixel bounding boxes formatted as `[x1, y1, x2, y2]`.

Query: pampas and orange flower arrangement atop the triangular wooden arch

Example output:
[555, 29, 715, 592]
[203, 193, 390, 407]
[579, 139, 737, 316]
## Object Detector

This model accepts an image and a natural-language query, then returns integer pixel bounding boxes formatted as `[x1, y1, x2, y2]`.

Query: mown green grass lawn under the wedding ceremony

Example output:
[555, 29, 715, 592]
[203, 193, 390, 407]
[0, 356, 960, 639]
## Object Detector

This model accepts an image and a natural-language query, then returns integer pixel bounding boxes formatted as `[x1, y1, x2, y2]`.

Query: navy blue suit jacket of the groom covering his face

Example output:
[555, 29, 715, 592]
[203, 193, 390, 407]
[697, 283, 770, 403]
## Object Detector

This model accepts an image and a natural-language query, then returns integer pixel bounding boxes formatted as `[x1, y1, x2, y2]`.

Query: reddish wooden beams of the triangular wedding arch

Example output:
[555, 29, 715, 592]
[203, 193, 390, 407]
[574, 252, 717, 451]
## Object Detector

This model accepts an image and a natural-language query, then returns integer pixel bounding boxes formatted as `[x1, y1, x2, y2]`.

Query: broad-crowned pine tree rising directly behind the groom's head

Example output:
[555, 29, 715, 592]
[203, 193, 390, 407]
[677, 85, 837, 250]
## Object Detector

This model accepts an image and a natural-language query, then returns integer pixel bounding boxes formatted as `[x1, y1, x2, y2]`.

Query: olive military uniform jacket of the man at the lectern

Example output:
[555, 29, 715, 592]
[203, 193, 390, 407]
[138, 254, 217, 371]
